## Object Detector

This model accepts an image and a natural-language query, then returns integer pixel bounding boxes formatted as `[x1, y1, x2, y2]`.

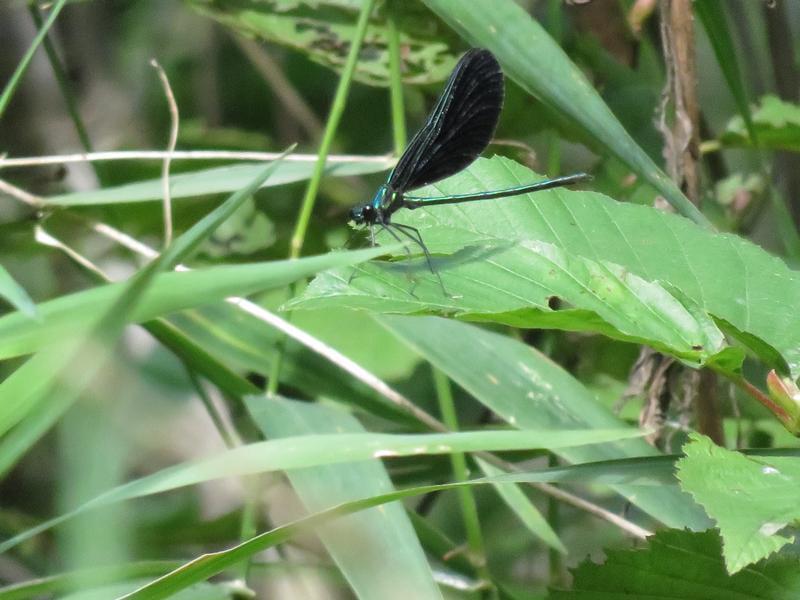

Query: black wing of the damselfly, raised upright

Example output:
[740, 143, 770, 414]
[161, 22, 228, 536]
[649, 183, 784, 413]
[387, 49, 503, 192]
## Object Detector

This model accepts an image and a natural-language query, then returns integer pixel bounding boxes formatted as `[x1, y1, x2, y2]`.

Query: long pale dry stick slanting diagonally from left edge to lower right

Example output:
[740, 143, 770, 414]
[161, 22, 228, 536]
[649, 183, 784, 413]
[0, 179, 651, 539]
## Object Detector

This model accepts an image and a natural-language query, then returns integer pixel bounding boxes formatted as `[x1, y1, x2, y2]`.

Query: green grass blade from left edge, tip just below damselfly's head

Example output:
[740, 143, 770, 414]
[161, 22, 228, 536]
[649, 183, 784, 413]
[0, 248, 394, 358]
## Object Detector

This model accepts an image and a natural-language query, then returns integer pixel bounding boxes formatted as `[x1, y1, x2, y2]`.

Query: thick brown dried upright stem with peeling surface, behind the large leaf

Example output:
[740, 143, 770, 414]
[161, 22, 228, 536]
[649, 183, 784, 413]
[660, 0, 725, 444]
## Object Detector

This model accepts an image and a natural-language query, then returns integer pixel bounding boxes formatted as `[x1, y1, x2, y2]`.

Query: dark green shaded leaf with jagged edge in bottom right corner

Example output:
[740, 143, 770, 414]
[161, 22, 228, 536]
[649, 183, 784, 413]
[548, 530, 800, 600]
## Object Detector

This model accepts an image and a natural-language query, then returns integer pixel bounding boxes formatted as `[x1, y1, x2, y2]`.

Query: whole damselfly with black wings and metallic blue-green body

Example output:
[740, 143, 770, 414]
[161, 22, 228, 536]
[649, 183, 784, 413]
[350, 48, 590, 295]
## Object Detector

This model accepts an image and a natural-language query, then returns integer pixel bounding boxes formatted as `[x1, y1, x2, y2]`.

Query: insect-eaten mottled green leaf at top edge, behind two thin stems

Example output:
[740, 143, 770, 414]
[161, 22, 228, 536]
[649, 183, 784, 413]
[190, 0, 456, 86]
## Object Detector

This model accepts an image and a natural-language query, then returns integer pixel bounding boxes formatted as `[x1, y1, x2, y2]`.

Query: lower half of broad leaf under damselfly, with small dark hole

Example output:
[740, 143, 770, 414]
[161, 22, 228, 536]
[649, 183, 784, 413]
[296, 234, 725, 364]
